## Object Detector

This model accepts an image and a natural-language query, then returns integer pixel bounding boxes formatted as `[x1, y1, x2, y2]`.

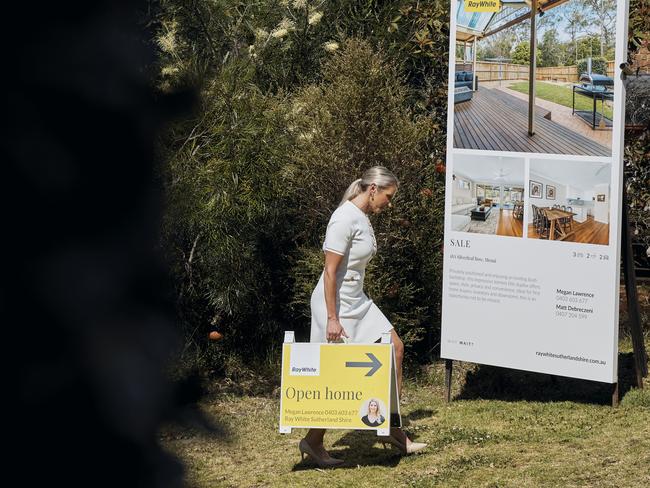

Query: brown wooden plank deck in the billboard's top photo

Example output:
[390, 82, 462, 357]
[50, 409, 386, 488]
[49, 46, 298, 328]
[454, 87, 612, 156]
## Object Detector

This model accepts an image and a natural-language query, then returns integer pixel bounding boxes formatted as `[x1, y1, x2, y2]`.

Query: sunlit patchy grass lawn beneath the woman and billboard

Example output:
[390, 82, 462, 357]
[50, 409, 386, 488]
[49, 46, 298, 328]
[160, 289, 650, 488]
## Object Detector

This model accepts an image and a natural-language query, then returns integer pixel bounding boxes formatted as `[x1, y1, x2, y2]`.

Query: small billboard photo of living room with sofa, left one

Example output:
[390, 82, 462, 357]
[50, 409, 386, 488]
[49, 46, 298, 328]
[449, 153, 525, 237]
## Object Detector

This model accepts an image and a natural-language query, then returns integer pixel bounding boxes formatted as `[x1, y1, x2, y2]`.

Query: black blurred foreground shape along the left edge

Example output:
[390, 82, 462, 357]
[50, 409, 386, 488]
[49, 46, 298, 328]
[2, 0, 197, 487]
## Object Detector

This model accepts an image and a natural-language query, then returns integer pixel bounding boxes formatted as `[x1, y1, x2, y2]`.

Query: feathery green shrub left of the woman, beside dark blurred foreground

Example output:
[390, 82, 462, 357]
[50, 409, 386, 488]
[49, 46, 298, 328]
[163, 58, 289, 370]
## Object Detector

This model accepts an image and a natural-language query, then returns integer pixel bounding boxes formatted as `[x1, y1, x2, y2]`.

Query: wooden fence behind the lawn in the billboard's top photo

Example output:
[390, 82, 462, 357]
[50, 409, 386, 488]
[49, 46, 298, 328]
[456, 61, 614, 83]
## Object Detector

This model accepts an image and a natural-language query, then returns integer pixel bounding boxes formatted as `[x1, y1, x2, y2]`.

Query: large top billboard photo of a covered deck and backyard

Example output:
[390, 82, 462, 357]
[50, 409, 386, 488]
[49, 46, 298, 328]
[450, 0, 616, 157]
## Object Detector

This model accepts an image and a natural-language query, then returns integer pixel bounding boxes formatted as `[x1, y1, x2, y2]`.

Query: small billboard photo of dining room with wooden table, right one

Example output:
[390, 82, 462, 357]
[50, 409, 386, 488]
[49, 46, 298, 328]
[527, 159, 611, 246]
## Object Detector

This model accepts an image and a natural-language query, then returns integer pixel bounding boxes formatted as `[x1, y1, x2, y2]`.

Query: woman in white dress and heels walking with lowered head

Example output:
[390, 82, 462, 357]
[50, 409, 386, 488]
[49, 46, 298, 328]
[299, 166, 426, 467]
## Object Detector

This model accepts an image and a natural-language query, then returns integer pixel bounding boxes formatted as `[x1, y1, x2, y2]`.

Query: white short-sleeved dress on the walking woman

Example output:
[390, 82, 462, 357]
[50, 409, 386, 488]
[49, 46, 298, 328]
[310, 201, 393, 343]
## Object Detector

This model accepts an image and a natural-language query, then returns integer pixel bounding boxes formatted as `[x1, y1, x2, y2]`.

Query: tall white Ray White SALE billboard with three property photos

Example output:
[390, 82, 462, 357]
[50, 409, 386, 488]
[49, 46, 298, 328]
[441, 0, 628, 382]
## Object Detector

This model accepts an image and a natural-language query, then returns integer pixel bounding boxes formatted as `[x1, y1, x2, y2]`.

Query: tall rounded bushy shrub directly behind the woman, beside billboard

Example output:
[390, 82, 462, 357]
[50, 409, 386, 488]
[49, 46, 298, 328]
[287, 40, 444, 345]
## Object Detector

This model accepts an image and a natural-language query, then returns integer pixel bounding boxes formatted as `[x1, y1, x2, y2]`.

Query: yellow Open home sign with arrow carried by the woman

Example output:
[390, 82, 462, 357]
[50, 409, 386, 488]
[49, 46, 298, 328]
[280, 334, 399, 434]
